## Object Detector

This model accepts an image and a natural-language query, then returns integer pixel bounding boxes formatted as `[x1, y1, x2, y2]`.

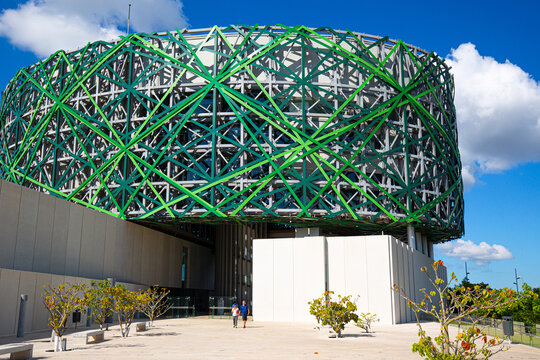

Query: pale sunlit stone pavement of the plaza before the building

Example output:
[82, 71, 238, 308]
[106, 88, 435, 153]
[0, 317, 540, 360]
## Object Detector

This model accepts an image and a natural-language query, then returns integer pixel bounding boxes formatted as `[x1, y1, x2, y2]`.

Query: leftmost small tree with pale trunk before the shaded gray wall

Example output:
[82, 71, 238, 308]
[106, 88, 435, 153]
[42, 282, 85, 352]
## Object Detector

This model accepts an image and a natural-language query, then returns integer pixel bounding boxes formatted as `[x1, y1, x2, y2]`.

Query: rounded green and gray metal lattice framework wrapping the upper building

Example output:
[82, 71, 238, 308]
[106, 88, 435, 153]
[0, 25, 463, 241]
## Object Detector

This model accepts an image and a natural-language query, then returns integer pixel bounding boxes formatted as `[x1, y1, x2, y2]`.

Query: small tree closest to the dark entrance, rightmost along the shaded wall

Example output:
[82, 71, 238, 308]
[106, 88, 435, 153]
[110, 285, 146, 337]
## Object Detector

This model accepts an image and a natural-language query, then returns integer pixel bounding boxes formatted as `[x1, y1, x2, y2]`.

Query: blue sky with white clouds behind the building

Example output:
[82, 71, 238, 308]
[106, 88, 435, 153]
[0, 0, 540, 287]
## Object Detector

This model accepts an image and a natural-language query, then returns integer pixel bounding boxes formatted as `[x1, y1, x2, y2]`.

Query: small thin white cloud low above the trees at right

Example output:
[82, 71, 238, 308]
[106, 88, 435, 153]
[435, 239, 514, 266]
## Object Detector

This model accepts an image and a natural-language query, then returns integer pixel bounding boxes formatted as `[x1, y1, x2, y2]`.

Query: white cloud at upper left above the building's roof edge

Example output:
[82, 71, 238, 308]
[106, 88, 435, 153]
[0, 0, 187, 58]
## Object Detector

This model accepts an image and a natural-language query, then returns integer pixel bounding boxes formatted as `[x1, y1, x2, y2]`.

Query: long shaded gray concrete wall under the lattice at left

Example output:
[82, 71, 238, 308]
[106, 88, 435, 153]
[0, 180, 214, 289]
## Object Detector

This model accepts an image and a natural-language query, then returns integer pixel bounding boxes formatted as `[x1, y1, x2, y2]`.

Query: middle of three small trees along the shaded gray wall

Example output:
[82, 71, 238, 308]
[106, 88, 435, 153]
[82, 279, 113, 329]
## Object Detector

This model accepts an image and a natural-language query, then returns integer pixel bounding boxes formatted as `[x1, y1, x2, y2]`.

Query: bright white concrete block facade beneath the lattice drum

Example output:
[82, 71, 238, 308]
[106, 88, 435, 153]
[253, 235, 446, 324]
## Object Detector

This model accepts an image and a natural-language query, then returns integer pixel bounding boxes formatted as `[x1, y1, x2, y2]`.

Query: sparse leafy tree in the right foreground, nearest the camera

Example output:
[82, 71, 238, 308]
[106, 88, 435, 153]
[394, 260, 519, 360]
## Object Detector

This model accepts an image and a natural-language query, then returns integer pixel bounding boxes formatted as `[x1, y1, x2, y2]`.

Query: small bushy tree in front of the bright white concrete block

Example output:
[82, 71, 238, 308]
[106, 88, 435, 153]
[308, 291, 358, 338]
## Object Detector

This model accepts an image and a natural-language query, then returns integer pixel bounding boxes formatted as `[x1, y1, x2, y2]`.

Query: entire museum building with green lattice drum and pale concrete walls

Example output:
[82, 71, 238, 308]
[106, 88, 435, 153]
[0, 25, 464, 335]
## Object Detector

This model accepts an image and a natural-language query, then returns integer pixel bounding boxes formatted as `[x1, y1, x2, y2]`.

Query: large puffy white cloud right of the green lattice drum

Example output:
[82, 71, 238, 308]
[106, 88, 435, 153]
[446, 43, 540, 187]
